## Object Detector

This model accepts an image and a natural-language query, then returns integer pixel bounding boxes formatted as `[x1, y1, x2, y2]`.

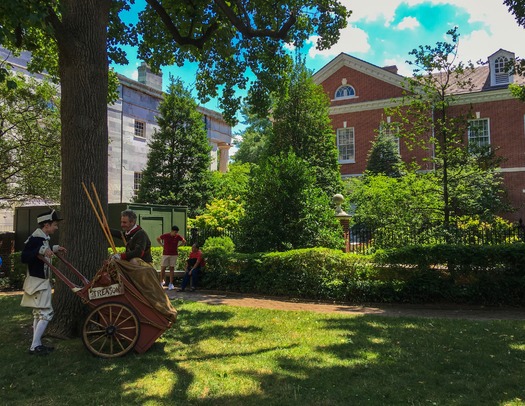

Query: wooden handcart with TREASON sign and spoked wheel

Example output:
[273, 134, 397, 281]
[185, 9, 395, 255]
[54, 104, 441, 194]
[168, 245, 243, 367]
[40, 255, 176, 358]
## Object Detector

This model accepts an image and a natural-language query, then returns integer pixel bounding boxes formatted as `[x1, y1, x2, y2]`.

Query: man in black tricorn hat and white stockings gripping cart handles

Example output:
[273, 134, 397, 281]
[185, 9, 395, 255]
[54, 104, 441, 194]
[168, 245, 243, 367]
[21, 210, 66, 355]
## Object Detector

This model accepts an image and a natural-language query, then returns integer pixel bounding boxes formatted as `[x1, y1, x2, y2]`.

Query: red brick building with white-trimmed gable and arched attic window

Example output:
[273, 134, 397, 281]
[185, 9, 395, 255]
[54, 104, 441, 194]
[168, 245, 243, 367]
[314, 49, 525, 221]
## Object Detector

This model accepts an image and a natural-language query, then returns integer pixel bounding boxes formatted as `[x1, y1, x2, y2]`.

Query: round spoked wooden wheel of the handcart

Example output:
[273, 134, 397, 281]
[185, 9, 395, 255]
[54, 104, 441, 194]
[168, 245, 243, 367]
[82, 303, 140, 358]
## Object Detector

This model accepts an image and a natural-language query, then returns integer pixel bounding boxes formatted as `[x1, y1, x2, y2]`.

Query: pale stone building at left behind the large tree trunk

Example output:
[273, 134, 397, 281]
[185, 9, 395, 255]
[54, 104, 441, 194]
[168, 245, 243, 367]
[0, 47, 232, 231]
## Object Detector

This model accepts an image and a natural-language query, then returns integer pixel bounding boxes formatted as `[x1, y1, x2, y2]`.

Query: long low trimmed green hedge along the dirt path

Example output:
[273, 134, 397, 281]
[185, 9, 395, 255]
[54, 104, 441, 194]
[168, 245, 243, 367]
[202, 243, 525, 305]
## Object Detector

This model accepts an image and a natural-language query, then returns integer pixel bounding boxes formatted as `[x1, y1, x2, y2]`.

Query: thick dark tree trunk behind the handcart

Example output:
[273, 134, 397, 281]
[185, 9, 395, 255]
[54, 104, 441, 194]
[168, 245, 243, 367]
[49, 0, 111, 336]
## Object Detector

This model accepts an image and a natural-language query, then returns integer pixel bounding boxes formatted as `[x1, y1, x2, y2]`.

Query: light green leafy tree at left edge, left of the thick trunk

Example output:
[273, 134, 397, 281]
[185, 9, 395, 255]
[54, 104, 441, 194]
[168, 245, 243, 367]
[0, 70, 61, 203]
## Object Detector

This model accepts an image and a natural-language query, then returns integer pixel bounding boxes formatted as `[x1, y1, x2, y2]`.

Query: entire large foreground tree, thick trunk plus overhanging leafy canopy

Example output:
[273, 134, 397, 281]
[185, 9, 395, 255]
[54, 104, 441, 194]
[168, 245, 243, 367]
[0, 0, 350, 336]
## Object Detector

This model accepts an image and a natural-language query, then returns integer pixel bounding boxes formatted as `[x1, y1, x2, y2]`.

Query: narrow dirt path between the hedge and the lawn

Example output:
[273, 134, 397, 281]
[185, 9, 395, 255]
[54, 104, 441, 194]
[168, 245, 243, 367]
[166, 290, 525, 320]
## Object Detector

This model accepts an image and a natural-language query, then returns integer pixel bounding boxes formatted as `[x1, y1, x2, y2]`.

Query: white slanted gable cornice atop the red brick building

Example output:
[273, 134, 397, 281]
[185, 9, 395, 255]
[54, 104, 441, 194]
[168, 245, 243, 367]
[313, 53, 404, 87]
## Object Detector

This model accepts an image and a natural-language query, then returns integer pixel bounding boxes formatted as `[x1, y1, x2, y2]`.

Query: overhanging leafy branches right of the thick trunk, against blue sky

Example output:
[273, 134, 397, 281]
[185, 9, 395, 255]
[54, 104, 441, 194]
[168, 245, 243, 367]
[135, 0, 350, 120]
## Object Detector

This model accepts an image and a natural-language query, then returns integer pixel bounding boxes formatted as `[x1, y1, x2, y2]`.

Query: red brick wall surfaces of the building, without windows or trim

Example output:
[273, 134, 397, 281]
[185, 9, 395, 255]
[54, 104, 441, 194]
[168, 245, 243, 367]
[322, 60, 525, 221]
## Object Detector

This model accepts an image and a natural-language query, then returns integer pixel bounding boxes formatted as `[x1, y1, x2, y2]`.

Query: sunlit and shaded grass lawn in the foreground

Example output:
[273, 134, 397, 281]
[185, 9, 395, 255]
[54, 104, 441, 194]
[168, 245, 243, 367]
[0, 295, 525, 406]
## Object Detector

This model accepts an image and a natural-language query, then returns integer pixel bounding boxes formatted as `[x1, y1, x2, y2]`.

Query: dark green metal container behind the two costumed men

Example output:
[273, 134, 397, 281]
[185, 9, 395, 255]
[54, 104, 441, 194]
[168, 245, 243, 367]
[14, 203, 188, 251]
